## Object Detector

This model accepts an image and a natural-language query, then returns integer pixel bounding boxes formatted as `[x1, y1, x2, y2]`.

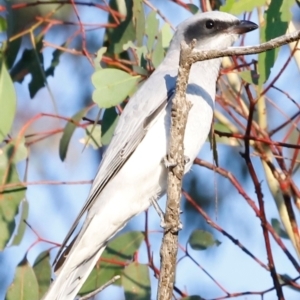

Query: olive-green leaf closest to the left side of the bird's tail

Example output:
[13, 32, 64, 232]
[33, 251, 51, 299]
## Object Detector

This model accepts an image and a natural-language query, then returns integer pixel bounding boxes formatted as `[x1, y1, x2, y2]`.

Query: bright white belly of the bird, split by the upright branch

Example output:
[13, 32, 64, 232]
[88, 90, 213, 227]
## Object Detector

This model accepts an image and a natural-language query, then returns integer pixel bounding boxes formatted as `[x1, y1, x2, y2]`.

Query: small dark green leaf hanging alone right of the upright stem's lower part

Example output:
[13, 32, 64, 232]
[188, 229, 221, 250]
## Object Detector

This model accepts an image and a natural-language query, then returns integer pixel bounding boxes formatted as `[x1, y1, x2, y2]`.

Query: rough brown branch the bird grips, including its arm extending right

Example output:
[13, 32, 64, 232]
[157, 30, 300, 300]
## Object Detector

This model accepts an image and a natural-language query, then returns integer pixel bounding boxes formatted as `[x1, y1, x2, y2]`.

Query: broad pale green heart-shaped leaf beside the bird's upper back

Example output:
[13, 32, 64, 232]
[92, 69, 140, 108]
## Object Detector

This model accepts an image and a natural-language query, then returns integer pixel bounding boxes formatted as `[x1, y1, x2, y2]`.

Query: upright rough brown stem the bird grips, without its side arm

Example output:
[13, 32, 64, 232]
[157, 42, 194, 300]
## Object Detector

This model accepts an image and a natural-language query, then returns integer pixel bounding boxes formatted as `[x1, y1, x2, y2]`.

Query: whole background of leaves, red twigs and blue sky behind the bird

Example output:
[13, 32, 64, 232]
[0, 0, 300, 300]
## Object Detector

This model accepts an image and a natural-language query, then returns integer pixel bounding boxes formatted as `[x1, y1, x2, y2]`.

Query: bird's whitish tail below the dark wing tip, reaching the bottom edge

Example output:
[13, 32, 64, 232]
[43, 243, 106, 300]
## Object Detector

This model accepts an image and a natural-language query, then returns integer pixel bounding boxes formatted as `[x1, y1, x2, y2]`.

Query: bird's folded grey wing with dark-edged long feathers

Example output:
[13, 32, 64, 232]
[53, 72, 176, 270]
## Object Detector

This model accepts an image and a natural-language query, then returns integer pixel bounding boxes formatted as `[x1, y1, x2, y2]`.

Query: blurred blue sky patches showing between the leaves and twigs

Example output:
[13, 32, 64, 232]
[0, 1, 300, 300]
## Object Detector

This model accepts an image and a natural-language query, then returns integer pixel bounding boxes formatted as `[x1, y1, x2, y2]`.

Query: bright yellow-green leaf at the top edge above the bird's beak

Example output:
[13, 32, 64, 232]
[220, 0, 266, 15]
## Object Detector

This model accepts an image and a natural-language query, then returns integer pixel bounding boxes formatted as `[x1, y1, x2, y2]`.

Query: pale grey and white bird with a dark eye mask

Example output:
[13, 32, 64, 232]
[43, 11, 258, 300]
